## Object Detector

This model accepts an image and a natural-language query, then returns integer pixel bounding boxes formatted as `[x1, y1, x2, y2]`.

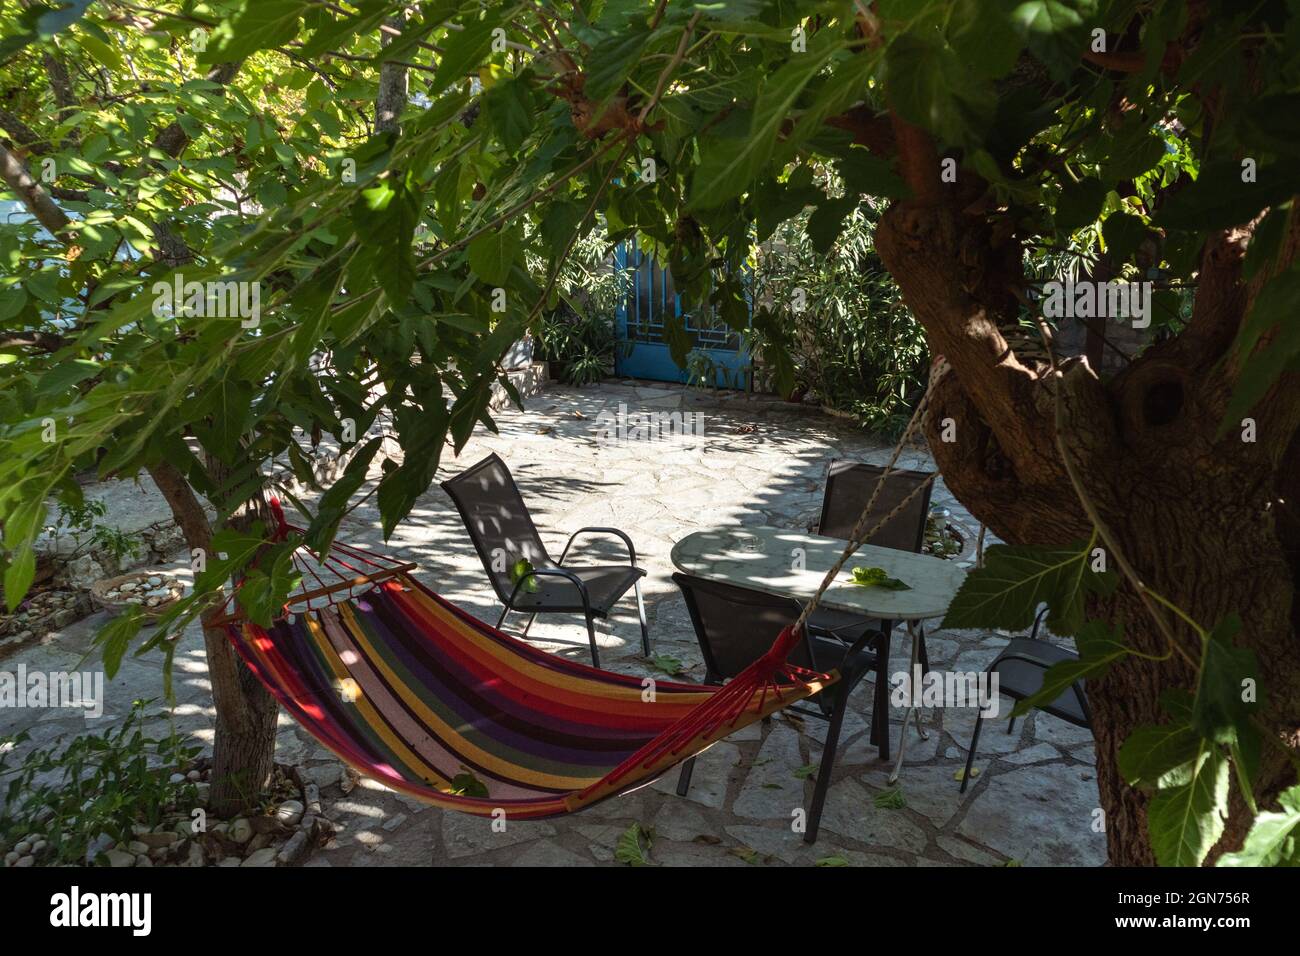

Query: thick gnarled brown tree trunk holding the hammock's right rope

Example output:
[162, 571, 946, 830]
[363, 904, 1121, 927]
[876, 174, 1300, 866]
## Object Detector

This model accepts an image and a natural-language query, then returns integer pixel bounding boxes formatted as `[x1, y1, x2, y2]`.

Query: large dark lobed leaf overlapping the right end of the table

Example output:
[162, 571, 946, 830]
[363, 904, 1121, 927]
[944, 542, 1115, 635]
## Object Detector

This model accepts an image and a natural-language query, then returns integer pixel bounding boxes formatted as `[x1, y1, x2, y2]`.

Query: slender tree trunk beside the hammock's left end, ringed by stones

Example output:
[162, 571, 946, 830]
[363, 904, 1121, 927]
[150, 462, 280, 817]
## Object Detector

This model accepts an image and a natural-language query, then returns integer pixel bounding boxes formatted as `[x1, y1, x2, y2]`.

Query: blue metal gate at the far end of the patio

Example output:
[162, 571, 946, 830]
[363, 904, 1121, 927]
[614, 238, 750, 389]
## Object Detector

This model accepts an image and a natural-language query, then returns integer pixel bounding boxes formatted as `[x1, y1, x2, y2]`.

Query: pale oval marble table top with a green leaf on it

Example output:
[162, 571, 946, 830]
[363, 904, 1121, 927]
[672, 527, 966, 620]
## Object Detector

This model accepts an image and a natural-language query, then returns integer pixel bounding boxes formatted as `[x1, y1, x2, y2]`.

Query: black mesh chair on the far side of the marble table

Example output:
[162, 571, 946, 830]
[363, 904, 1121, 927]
[809, 459, 933, 738]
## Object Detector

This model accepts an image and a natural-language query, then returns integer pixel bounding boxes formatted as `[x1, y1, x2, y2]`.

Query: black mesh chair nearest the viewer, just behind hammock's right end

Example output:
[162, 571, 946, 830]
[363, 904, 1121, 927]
[672, 574, 889, 843]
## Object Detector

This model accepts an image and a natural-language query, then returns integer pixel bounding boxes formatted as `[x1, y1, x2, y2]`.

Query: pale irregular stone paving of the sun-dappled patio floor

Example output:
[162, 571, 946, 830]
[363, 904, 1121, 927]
[0, 382, 1105, 866]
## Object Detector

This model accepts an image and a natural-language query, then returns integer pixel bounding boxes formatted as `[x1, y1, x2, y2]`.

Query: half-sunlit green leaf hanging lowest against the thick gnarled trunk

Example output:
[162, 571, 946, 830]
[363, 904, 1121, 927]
[1147, 740, 1229, 866]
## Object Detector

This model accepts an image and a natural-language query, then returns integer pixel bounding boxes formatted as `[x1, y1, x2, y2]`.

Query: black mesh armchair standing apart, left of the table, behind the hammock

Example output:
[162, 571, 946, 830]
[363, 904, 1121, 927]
[442, 455, 650, 667]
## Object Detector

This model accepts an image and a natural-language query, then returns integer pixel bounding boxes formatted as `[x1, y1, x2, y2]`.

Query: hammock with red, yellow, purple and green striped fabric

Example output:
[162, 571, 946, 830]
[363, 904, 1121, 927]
[226, 525, 837, 818]
